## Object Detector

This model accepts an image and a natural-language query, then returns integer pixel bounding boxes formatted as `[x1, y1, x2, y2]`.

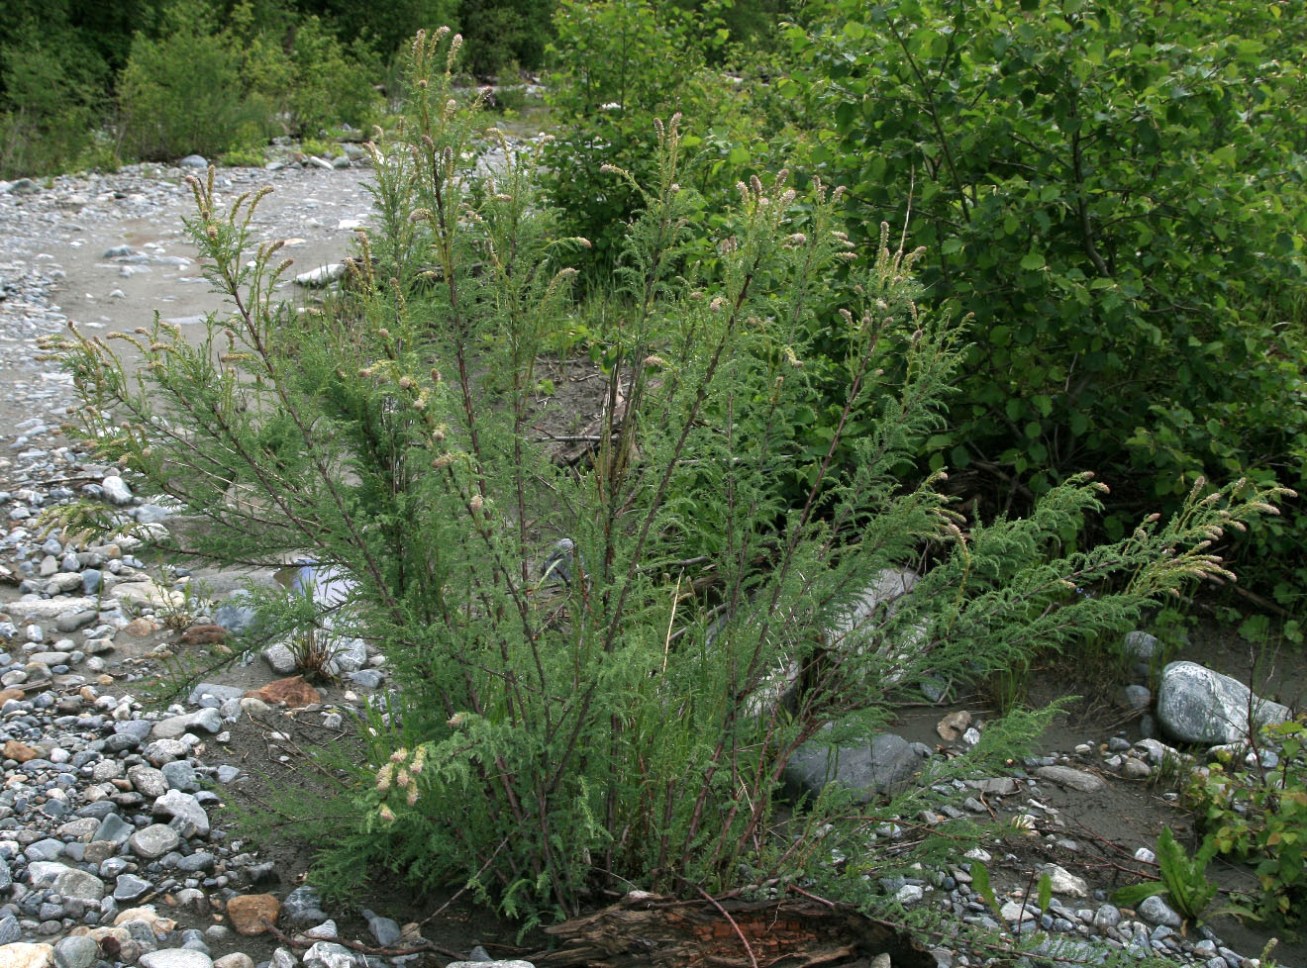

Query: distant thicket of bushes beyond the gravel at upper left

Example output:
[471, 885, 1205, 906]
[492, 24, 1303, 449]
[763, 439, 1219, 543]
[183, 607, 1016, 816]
[0, 0, 553, 178]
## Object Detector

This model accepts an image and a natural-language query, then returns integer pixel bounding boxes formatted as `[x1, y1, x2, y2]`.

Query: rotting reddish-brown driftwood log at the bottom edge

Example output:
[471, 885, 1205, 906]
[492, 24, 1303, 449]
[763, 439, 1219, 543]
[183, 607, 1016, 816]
[525, 892, 936, 968]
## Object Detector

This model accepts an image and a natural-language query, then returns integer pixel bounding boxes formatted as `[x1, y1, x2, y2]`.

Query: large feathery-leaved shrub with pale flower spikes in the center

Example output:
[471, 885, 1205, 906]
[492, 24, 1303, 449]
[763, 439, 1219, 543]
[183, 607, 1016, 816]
[56, 28, 1281, 917]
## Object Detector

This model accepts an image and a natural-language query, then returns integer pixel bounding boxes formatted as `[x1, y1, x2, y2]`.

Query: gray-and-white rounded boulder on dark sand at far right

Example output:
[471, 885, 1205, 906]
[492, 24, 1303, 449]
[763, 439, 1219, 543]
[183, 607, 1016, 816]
[1157, 662, 1290, 746]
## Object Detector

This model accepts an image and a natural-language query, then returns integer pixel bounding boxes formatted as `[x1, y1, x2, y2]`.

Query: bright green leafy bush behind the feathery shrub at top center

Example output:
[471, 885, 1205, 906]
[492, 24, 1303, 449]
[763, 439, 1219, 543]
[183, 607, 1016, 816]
[545, 0, 797, 273]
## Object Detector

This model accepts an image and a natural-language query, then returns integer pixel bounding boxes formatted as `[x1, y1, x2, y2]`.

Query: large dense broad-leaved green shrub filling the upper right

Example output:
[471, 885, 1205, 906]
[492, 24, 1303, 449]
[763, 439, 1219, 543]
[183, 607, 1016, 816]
[784, 0, 1307, 606]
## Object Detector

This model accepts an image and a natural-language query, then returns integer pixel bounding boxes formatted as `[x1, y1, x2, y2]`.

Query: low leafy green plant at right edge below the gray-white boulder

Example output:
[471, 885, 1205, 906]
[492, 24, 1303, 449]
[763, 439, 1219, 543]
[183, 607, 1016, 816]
[1188, 722, 1307, 930]
